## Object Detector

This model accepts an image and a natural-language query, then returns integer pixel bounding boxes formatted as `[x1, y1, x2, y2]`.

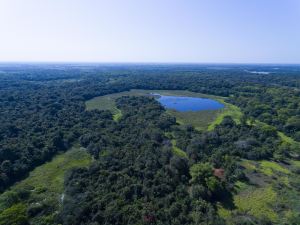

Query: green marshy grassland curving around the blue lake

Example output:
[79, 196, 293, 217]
[85, 89, 242, 130]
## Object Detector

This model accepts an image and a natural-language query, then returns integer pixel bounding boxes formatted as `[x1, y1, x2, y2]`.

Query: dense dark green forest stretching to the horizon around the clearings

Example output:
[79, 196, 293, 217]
[0, 64, 300, 225]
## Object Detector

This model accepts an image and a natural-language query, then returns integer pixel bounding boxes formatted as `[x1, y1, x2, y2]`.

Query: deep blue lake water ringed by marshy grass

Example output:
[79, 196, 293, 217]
[154, 94, 224, 112]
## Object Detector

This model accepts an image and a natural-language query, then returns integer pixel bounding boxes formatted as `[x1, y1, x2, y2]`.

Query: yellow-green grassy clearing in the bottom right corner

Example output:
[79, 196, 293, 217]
[218, 160, 300, 224]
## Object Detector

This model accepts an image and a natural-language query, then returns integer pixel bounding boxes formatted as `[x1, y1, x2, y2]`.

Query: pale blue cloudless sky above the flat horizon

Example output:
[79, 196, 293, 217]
[0, 0, 300, 64]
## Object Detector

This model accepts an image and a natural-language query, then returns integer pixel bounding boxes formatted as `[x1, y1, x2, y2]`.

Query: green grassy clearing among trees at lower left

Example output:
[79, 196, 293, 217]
[0, 147, 92, 224]
